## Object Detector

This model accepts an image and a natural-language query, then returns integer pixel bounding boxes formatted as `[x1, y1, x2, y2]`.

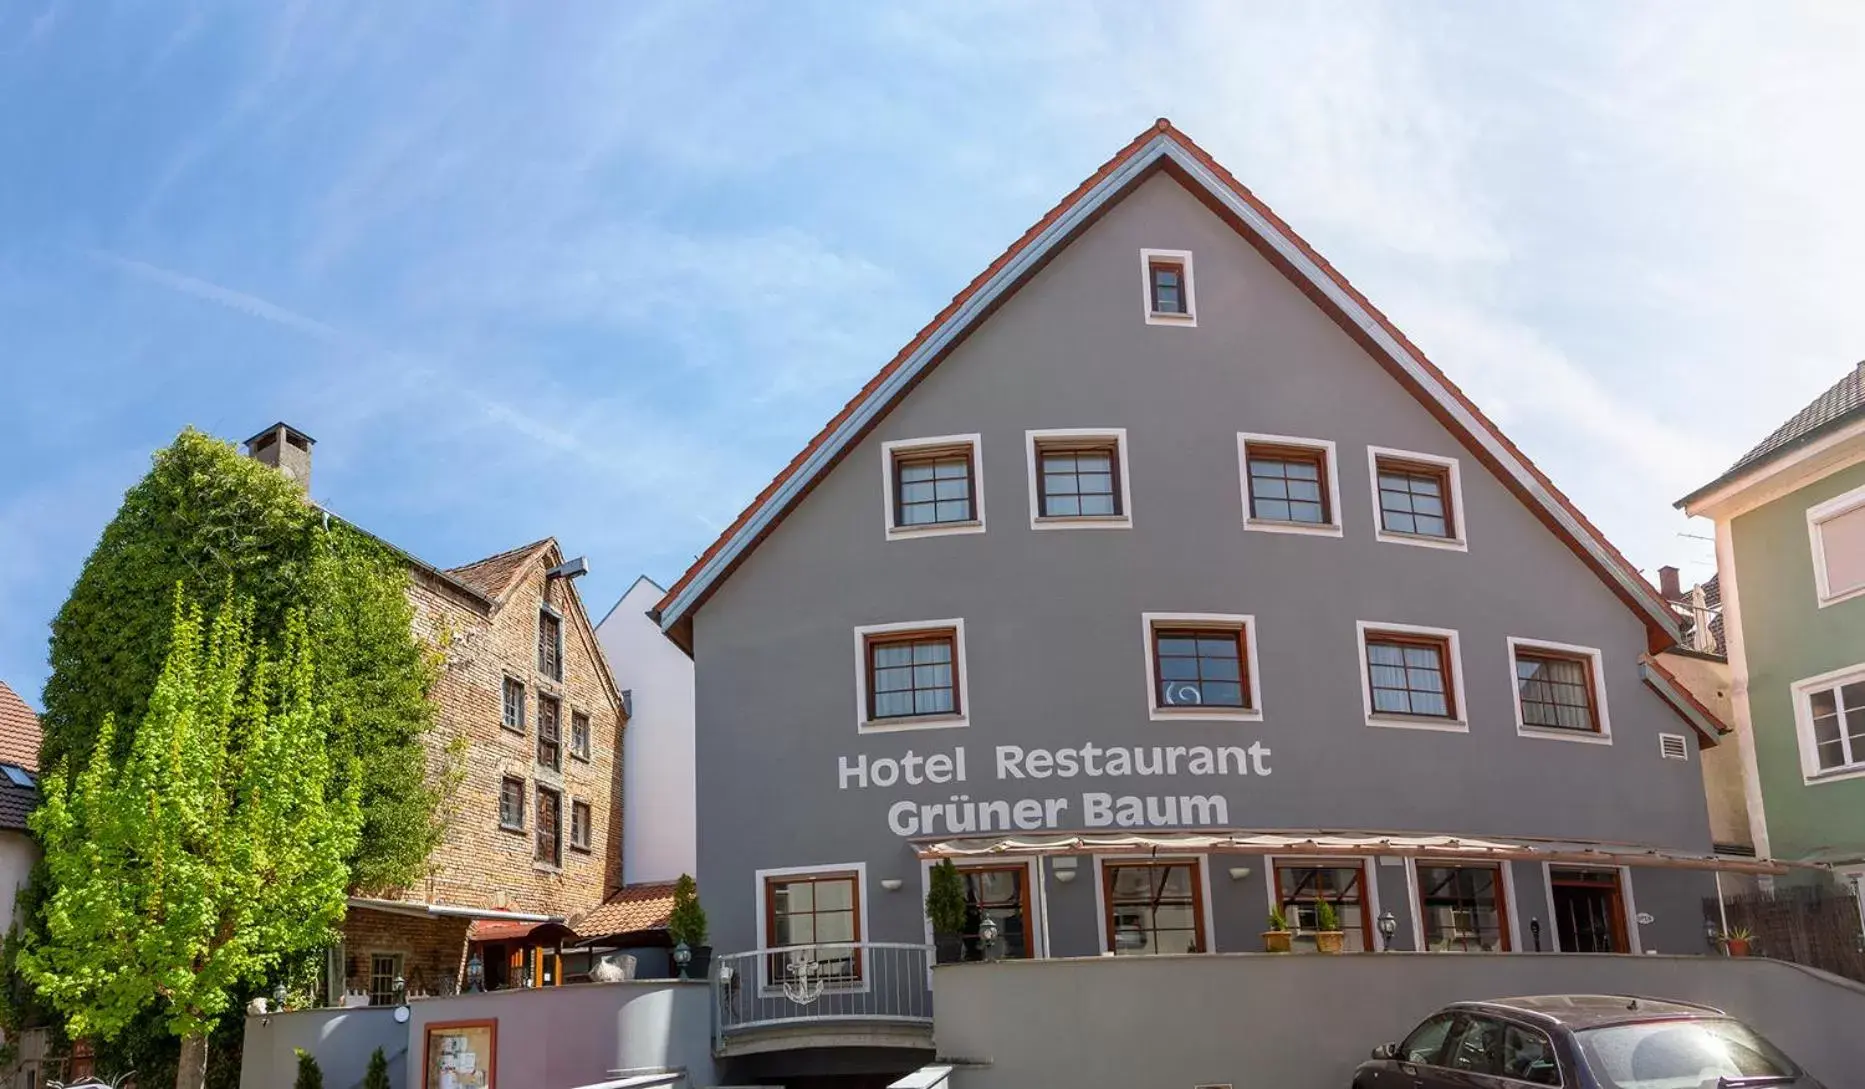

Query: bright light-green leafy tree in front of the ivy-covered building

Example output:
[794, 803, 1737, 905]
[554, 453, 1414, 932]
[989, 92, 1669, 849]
[17, 589, 362, 1085]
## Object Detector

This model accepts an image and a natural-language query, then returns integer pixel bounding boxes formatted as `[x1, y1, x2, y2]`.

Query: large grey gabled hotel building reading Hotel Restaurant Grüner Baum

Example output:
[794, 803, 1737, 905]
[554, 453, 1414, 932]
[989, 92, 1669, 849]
[656, 121, 1772, 1080]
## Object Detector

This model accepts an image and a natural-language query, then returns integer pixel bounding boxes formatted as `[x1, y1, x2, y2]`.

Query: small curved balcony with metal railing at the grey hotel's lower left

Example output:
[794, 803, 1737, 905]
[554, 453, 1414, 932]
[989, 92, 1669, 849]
[712, 942, 933, 1055]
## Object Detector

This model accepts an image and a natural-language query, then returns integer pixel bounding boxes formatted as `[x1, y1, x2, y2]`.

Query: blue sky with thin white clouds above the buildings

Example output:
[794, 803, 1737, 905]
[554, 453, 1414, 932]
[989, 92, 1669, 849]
[0, 0, 1865, 701]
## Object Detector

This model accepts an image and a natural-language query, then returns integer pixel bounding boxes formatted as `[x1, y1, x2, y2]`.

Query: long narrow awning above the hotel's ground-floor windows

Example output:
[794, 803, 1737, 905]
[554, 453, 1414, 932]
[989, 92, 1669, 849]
[914, 830, 1794, 875]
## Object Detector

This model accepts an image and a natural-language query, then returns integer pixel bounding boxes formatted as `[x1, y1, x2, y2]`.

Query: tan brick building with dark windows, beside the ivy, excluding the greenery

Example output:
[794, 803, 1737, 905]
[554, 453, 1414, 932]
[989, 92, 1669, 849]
[246, 423, 625, 1005]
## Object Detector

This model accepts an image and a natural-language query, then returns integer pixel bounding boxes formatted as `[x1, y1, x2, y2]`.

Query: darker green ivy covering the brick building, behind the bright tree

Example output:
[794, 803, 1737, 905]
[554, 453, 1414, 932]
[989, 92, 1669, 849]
[41, 429, 440, 891]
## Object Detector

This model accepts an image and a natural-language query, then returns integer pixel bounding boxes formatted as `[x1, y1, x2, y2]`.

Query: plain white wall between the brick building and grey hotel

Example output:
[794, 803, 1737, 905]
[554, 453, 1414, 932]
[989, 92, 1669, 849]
[597, 574, 698, 884]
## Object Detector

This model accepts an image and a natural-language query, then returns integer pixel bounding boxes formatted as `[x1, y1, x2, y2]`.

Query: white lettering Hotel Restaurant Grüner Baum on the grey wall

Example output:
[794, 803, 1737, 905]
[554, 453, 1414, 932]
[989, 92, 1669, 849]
[836, 742, 1270, 835]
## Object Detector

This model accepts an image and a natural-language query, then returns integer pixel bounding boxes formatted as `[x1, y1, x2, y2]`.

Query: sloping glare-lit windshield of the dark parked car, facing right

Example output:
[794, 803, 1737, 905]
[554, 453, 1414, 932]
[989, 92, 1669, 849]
[1576, 1020, 1800, 1089]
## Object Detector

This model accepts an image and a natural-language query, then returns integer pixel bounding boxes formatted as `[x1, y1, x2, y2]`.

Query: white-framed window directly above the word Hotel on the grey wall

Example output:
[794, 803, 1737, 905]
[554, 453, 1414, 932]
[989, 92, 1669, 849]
[854, 619, 972, 733]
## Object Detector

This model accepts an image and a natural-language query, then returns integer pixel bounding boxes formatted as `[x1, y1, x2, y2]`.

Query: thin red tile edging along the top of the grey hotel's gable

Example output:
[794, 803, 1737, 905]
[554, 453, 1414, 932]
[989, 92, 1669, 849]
[655, 117, 1669, 634]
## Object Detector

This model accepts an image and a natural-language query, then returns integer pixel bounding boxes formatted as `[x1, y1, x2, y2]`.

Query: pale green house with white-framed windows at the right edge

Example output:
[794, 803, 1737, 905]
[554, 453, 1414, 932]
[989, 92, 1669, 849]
[1677, 364, 1865, 898]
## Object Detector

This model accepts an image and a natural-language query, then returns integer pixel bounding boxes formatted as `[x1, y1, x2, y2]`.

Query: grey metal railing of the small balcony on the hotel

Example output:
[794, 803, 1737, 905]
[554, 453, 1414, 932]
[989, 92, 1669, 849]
[712, 942, 933, 1044]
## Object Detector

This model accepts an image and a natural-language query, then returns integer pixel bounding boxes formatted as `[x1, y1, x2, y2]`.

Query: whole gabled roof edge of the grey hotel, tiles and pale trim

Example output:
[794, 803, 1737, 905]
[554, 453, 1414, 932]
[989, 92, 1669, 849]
[655, 117, 1677, 653]
